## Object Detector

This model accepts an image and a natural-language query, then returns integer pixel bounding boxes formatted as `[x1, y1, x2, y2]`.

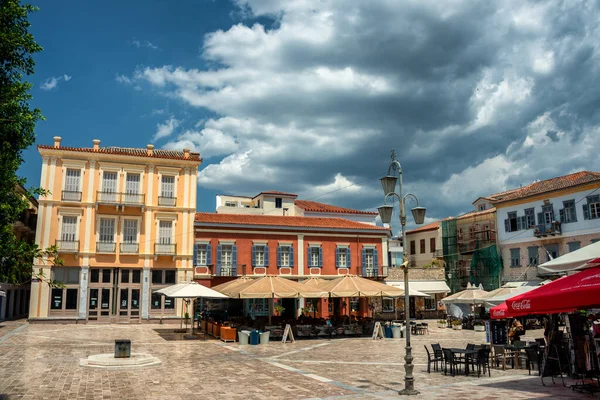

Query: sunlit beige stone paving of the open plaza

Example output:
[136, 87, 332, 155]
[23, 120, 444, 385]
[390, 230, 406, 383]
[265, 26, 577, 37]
[0, 321, 594, 399]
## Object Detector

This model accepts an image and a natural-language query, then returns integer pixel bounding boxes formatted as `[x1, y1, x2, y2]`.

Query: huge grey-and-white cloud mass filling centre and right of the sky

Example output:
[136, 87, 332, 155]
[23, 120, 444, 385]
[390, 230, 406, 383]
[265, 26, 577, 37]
[127, 0, 600, 221]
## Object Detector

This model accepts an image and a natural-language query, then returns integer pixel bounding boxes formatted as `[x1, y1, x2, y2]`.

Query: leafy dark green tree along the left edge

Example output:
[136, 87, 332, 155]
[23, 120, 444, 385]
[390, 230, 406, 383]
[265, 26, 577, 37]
[0, 0, 55, 284]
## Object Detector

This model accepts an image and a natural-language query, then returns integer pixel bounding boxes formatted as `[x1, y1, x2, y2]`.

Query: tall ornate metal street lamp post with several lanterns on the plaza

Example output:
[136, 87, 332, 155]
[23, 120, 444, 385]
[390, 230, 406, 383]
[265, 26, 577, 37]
[378, 149, 426, 396]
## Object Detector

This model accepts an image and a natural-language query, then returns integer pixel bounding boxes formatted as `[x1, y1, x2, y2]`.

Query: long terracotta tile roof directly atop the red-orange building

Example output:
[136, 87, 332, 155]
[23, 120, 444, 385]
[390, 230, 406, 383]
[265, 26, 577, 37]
[195, 213, 389, 233]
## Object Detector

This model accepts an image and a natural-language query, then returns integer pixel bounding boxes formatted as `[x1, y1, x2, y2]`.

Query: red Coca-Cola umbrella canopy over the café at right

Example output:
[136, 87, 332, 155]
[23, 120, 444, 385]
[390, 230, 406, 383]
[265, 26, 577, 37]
[506, 267, 600, 316]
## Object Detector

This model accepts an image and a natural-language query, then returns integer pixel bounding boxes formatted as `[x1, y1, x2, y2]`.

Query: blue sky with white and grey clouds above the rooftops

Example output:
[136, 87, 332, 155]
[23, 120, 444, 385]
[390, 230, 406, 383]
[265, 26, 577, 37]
[20, 0, 600, 231]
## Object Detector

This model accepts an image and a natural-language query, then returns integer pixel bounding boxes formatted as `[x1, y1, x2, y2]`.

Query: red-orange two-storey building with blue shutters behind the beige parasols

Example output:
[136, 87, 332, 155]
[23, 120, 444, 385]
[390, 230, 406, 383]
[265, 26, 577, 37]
[194, 213, 390, 318]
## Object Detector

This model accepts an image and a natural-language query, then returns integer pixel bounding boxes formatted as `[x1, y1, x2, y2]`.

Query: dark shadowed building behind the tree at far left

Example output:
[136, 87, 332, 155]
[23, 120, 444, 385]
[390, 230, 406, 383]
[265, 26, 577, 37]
[0, 186, 38, 321]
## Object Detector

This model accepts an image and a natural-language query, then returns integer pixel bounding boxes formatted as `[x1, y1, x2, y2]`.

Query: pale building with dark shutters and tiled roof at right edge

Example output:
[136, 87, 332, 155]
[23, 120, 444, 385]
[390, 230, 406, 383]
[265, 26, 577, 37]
[494, 171, 600, 281]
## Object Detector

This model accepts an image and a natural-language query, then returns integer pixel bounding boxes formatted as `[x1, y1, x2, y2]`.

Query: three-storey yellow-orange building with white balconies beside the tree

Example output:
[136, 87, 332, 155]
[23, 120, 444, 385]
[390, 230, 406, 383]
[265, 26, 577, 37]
[29, 137, 202, 322]
